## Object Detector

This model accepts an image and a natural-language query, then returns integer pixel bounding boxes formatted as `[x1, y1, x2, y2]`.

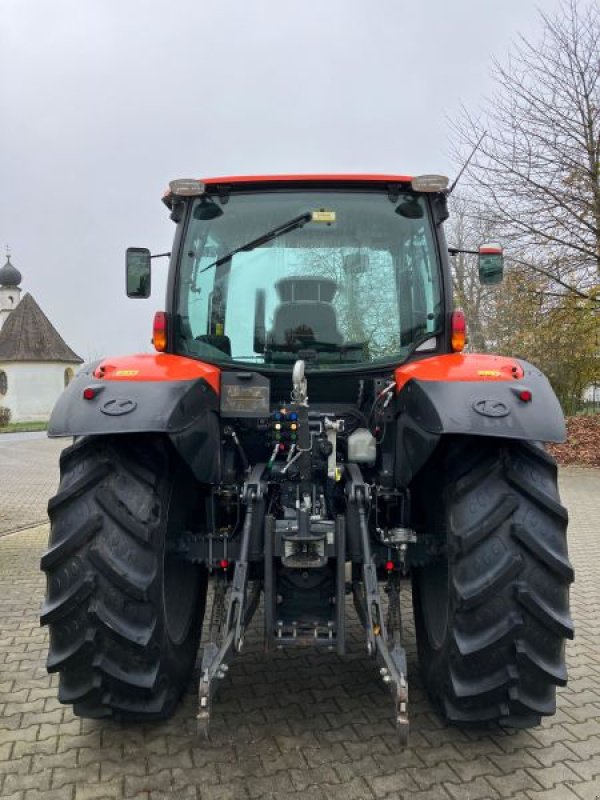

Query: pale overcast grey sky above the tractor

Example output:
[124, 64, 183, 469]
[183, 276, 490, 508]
[0, 0, 560, 361]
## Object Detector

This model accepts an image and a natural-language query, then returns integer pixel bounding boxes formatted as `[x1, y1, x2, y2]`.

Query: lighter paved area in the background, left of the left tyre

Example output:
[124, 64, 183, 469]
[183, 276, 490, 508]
[0, 434, 63, 536]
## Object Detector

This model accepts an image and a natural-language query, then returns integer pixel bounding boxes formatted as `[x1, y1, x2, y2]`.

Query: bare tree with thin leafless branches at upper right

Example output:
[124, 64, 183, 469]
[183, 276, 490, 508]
[454, 0, 600, 297]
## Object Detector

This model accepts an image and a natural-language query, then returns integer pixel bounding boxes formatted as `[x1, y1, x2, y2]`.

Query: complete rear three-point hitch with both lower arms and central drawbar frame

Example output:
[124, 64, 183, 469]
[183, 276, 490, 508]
[197, 464, 409, 745]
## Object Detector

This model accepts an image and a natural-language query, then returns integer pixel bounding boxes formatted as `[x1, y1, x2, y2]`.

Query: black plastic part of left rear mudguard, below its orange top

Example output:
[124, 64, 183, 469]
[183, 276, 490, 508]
[48, 362, 221, 483]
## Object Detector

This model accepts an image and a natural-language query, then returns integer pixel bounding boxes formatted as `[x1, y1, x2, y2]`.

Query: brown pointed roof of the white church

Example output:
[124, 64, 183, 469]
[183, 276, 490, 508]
[0, 294, 83, 364]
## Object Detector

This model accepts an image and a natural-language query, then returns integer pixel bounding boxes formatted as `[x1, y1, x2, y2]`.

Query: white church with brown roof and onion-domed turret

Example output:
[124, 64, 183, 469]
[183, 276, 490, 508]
[0, 256, 83, 422]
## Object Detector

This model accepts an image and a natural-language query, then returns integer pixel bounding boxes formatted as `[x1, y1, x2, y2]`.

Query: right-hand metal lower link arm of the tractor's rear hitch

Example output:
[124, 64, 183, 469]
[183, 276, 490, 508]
[346, 464, 409, 746]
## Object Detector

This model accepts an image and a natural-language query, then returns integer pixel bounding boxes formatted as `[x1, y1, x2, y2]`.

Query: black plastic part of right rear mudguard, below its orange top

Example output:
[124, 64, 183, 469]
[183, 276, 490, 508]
[395, 361, 567, 486]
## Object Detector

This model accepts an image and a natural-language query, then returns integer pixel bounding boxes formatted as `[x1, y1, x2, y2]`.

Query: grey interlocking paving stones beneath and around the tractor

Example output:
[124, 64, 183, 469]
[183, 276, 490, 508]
[0, 469, 600, 800]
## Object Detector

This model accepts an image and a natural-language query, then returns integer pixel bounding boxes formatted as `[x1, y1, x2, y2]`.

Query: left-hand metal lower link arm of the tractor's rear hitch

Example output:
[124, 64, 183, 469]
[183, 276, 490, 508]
[196, 464, 264, 736]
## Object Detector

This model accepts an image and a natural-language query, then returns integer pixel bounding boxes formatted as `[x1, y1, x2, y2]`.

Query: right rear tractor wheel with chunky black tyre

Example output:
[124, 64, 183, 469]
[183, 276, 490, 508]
[413, 440, 573, 728]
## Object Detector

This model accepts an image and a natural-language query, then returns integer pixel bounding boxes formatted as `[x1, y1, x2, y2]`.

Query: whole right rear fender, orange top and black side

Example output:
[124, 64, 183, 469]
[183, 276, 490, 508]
[395, 354, 566, 486]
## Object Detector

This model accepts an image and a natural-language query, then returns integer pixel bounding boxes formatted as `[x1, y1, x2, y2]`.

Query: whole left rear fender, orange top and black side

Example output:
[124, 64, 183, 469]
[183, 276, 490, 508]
[48, 354, 221, 483]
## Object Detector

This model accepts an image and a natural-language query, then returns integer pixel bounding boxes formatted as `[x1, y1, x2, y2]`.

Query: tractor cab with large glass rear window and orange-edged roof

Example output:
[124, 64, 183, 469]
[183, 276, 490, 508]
[129, 176, 450, 372]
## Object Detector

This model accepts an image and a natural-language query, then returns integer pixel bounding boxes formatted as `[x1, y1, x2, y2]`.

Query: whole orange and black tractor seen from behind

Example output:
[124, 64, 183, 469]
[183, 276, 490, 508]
[41, 175, 573, 742]
